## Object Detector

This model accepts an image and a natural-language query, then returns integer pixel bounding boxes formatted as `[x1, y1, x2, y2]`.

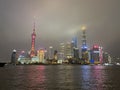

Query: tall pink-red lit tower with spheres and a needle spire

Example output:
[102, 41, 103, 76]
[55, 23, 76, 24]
[30, 23, 36, 57]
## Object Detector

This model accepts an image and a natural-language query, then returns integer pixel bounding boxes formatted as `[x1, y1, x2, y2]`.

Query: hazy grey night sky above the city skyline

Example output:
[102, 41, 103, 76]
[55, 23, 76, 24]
[0, 0, 120, 61]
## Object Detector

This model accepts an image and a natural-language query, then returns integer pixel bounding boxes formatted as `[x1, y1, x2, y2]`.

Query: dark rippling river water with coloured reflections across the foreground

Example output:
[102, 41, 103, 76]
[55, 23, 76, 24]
[0, 65, 120, 90]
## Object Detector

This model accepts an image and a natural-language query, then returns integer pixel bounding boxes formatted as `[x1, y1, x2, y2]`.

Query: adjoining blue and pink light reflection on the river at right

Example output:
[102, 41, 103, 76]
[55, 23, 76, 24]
[81, 66, 106, 90]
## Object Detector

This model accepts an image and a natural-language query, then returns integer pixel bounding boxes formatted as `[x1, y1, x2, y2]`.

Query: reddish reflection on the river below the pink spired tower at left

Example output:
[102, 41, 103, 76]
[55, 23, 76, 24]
[27, 66, 47, 90]
